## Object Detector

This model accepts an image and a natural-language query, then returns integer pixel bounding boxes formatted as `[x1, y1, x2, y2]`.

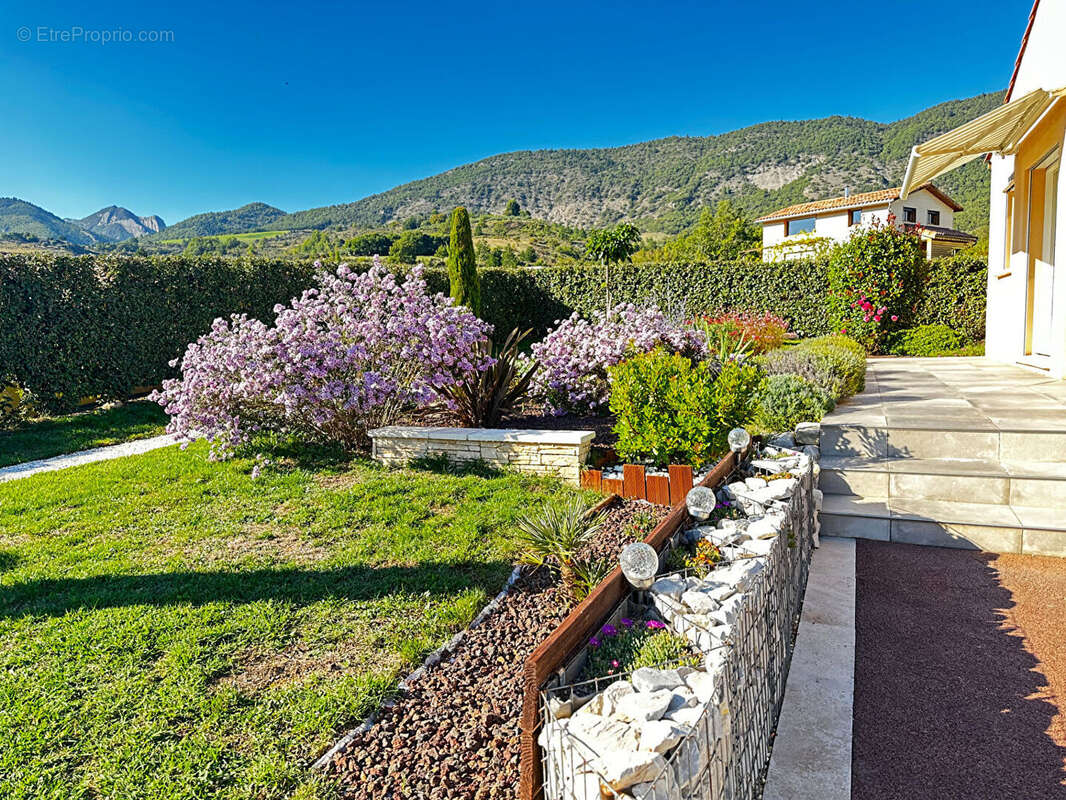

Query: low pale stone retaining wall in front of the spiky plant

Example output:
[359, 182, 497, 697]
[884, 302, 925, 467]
[370, 426, 596, 485]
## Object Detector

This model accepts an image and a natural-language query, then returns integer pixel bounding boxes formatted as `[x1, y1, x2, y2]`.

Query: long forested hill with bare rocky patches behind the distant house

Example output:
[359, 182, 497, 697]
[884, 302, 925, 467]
[270, 92, 1003, 231]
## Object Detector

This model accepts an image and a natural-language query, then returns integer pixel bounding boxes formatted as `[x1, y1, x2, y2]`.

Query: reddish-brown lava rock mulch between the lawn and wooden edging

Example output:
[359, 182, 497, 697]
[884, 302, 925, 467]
[326, 501, 669, 800]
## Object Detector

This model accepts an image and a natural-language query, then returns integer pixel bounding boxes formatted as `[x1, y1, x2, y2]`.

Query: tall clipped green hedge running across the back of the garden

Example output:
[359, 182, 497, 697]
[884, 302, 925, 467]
[0, 254, 985, 410]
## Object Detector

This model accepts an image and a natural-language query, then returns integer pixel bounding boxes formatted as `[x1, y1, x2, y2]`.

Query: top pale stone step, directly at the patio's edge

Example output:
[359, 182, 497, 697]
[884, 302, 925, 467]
[821, 417, 1066, 462]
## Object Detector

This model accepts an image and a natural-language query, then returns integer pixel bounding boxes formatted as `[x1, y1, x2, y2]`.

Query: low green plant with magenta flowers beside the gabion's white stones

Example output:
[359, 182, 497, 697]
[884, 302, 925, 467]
[583, 618, 699, 678]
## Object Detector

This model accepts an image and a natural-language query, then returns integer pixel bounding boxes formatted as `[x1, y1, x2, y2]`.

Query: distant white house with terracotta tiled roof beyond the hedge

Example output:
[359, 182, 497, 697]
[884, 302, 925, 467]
[756, 183, 978, 261]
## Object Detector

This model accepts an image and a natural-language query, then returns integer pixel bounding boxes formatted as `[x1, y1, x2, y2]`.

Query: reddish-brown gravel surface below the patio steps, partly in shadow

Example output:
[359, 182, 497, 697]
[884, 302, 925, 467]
[852, 540, 1066, 800]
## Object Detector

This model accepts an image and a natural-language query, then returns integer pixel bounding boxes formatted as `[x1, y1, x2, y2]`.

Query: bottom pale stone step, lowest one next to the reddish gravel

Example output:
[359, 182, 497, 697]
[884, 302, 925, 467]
[821, 494, 1066, 556]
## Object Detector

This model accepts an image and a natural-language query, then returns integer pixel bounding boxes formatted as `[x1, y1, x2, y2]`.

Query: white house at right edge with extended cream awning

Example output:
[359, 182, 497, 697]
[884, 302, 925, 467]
[903, 0, 1066, 378]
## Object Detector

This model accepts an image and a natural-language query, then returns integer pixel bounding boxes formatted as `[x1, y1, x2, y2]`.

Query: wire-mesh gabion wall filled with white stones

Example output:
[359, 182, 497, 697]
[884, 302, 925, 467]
[538, 447, 817, 800]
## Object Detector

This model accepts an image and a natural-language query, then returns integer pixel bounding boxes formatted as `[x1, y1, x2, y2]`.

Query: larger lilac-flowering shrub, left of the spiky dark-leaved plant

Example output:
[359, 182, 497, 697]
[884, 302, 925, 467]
[154, 259, 491, 455]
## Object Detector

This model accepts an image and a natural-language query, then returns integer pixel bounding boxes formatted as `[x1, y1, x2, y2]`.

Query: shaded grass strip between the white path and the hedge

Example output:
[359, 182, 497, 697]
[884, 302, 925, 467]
[0, 400, 166, 467]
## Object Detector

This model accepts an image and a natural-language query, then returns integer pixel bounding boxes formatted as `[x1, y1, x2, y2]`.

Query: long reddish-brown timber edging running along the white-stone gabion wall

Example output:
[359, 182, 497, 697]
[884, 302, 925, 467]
[518, 451, 739, 800]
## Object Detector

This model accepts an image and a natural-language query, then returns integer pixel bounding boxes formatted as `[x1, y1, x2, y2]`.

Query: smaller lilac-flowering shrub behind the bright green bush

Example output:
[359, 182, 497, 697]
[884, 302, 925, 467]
[531, 304, 707, 414]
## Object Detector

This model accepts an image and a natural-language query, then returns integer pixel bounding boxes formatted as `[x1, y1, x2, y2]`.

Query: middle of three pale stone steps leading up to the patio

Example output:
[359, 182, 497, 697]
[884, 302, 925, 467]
[819, 455, 1066, 508]
